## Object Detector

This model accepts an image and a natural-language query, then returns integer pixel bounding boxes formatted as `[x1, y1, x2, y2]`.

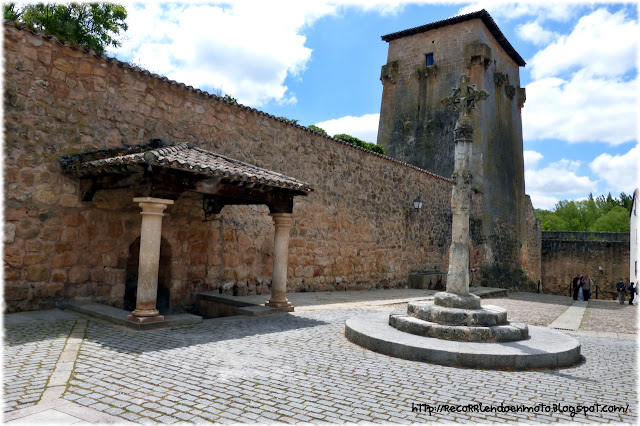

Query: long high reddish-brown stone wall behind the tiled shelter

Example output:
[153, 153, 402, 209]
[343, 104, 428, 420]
[4, 24, 451, 312]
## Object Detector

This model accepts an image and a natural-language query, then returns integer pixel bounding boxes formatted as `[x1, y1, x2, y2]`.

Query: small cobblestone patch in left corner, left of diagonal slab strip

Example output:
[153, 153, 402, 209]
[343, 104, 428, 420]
[2, 320, 75, 412]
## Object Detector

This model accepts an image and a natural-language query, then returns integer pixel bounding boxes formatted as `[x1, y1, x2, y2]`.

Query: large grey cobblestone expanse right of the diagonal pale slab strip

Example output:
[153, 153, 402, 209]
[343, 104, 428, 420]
[5, 292, 638, 424]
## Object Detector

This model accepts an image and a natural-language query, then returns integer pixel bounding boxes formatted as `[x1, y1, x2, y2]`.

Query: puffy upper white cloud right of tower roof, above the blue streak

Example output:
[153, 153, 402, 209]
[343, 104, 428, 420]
[529, 9, 640, 79]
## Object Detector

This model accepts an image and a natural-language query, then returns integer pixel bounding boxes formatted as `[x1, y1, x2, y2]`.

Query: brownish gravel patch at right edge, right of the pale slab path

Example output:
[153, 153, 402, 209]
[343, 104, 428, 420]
[580, 299, 638, 333]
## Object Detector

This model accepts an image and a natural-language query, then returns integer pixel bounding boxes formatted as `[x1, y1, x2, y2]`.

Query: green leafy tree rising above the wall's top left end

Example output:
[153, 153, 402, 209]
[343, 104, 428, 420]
[4, 3, 128, 53]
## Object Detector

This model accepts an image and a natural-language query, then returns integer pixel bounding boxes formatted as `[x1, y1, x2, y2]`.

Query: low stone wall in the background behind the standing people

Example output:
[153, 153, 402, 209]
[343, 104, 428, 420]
[542, 231, 629, 299]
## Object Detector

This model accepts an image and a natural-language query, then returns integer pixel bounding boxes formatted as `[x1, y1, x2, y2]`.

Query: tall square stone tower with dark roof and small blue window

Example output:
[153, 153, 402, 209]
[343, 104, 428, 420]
[378, 10, 526, 279]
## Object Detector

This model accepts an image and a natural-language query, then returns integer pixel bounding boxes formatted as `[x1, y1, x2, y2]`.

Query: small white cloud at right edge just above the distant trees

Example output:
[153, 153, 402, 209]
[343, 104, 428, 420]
[589, 145, 640, 194]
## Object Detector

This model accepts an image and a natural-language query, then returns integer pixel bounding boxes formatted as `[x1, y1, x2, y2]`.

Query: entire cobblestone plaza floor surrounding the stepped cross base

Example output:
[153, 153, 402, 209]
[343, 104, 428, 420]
[3, 291, 637, 424]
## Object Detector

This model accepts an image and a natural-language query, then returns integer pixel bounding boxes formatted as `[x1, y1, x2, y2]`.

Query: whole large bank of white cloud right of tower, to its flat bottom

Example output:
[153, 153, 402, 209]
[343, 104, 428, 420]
[522, 9, 640, 145]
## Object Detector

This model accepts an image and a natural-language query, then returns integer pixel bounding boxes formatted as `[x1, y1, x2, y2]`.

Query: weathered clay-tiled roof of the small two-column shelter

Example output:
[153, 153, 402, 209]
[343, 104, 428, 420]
[60, 141, 313, 194]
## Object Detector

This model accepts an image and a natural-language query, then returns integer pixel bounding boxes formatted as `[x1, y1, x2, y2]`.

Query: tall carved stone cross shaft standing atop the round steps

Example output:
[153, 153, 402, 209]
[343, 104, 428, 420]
[442, 74, 489, 300]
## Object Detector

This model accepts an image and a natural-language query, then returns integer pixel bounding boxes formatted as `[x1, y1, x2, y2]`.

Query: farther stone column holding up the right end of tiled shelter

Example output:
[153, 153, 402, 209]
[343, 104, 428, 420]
[265, 213, 293, 311]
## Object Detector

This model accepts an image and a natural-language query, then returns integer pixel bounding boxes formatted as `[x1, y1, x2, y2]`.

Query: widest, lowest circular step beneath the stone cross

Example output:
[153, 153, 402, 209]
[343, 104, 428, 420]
[344, 312, 583, 370]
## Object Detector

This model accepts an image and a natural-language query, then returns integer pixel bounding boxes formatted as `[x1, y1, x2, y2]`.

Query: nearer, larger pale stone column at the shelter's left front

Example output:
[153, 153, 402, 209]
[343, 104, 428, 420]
[127, 197, 173, 323]
